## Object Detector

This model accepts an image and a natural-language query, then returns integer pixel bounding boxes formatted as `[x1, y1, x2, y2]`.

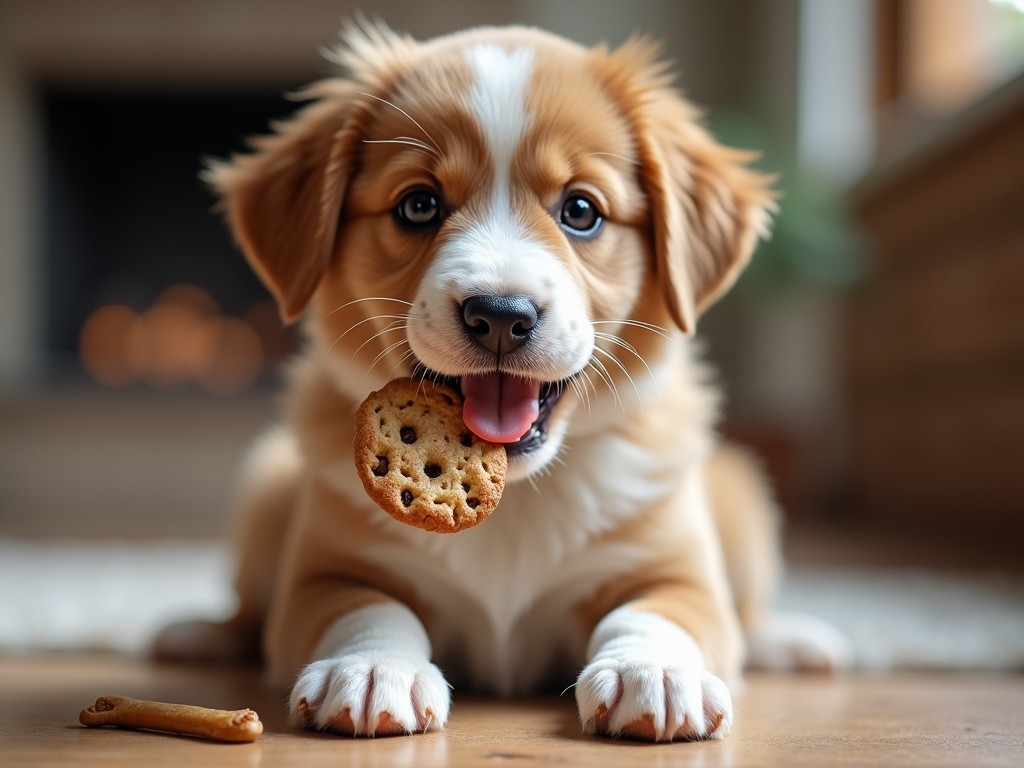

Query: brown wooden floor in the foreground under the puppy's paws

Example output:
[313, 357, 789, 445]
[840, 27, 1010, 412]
[0, 656, 1024, 768]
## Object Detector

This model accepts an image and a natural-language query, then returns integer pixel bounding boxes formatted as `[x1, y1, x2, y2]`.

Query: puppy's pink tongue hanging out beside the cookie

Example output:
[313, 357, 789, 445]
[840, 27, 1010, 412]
[462, 374, 541, 442]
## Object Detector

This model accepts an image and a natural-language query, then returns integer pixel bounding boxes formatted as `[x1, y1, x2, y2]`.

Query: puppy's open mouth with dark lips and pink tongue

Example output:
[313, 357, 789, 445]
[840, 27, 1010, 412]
[413, 361, 569, 458]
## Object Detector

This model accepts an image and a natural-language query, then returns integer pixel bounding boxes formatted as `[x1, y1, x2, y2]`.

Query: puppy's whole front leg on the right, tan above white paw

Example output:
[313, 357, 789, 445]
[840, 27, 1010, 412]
[575, 460, 743, 741]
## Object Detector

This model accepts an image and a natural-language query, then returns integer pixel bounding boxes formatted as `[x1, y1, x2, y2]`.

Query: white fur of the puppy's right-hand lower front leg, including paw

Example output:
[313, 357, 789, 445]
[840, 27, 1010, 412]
[575, 606, 732, 741]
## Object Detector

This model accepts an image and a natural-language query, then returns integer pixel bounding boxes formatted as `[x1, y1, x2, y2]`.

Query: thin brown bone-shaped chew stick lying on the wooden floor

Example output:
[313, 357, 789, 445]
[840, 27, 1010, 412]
[78, 696, 263, 741]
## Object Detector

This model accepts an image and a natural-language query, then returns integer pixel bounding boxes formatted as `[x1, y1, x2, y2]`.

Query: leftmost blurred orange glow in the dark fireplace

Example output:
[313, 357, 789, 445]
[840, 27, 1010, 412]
[79, 304, 150, 387]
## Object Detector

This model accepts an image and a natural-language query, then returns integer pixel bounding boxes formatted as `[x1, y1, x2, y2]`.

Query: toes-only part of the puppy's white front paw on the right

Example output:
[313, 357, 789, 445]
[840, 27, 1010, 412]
[577, 656, 732, 741]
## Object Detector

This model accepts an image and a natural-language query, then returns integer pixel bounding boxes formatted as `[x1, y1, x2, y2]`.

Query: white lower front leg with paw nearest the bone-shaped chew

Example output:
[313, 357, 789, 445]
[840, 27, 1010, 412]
[290, 602, 450, 736]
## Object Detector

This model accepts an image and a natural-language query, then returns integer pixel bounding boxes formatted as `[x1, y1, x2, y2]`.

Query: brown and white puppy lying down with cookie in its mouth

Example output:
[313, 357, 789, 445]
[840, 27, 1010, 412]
[159, 20, 847, 740]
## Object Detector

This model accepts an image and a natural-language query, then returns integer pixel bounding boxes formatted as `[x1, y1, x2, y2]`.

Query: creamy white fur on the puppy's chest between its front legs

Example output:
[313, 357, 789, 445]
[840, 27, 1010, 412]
[315, 339, 714, 693]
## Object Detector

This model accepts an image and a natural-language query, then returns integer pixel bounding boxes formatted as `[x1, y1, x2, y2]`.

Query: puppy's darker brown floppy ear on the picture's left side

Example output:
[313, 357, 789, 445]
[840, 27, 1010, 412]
[203, 78, 359, 323]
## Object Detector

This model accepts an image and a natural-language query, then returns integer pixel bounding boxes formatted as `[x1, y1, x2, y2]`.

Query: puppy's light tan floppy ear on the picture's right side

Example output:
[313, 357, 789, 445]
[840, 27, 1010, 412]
[638, 78, 776, 335]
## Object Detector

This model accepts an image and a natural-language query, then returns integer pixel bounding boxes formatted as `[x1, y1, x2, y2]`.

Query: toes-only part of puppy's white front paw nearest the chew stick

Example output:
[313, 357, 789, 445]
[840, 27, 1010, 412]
[290, 653, 450, 736]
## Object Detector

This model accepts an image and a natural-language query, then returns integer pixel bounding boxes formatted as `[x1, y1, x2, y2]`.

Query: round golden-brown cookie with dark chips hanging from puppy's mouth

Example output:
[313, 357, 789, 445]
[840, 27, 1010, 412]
[355, 379, 508, 534]
